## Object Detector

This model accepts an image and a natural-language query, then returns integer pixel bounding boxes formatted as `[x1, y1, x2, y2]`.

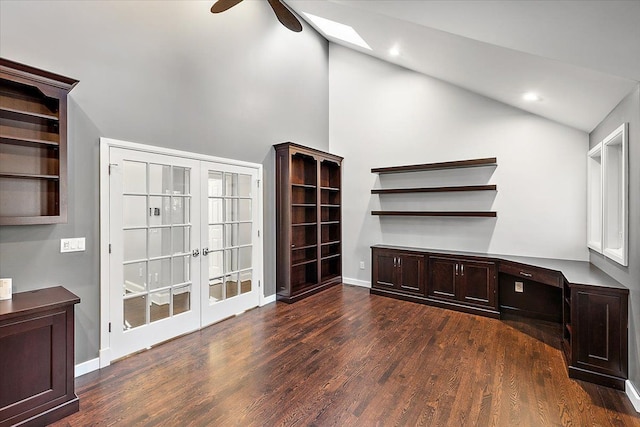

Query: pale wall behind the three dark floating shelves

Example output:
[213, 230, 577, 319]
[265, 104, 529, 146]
[329, 44, 588, 281]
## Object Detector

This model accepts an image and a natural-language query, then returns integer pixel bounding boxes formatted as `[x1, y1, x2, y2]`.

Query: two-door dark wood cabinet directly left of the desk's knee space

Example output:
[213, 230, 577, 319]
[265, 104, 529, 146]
[427, 256, 498, 315]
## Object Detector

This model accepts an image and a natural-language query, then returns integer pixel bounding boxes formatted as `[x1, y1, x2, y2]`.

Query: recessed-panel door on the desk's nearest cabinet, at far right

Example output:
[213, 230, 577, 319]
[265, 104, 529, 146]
[573, 290, 627, 377]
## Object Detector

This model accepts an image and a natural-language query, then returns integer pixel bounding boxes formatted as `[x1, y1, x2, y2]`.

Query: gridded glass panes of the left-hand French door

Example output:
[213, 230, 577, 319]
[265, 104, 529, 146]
[122, 160, 192, 331]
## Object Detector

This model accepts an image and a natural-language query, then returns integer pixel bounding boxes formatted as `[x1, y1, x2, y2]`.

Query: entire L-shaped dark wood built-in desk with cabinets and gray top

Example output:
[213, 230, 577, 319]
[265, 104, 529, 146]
[371, 245, 629, 390]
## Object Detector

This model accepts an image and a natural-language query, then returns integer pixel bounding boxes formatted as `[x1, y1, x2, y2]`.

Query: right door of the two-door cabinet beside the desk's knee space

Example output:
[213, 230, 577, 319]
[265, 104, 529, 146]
[459, 261, 496, 307]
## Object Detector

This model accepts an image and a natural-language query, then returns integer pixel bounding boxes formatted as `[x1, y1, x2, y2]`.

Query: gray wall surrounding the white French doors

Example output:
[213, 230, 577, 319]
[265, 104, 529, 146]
[0, 0, 329, 363]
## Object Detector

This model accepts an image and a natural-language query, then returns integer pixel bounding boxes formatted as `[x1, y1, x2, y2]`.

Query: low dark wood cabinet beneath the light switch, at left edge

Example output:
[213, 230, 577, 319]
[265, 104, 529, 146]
[0, 286, 80, 427]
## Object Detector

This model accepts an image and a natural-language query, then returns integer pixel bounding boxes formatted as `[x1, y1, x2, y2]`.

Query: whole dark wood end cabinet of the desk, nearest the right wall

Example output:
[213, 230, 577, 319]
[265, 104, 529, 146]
[564, 284, 629, 390]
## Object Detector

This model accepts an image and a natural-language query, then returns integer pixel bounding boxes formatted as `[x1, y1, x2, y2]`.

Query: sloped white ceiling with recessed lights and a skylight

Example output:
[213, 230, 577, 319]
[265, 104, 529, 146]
[286, 0, 640, 132]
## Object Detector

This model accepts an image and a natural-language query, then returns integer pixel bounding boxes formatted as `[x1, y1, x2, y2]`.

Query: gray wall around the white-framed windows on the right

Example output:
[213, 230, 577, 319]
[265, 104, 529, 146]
[589, 85, 640, 396]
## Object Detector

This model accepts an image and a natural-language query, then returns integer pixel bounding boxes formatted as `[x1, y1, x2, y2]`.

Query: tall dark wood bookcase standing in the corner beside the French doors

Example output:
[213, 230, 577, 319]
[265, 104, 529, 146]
[274, 142, 342, 303]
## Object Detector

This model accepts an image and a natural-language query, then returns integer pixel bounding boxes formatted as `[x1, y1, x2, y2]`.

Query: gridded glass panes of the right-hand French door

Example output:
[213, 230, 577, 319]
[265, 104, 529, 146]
[207, 171, 254, 305]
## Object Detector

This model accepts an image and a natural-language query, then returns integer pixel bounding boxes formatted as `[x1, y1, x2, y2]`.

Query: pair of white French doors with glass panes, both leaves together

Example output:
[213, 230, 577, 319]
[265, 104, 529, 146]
[106, 146, 262, 360]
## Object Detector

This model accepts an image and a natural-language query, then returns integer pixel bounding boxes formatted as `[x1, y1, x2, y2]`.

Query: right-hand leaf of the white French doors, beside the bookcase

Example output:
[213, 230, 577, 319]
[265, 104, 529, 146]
[200, 162, 261, 326]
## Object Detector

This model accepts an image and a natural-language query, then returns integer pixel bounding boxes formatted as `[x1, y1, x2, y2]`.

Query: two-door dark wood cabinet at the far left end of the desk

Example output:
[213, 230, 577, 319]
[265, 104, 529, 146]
[372, 251, 426, 296]
